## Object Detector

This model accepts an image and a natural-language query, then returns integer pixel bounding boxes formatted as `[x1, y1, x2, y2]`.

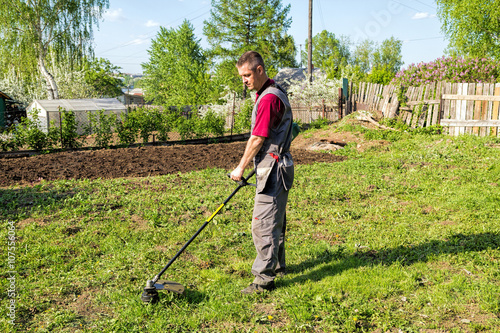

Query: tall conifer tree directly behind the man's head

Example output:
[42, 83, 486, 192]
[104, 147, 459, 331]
[203, 0, 296, 91]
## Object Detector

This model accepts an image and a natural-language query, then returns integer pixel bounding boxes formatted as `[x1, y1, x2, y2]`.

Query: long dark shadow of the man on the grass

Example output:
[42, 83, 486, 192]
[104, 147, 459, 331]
[281, 232, 500, 286]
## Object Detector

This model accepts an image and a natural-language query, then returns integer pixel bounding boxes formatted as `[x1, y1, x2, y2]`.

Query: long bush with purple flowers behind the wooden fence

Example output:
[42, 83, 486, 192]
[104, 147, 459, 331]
[391, 57, 500, 87]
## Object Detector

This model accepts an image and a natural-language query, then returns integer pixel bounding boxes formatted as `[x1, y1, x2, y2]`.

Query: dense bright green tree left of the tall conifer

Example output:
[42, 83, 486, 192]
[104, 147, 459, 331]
[141, 21, 210, 106]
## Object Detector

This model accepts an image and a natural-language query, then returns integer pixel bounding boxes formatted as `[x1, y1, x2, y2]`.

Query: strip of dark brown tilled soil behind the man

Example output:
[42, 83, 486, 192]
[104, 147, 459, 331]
[0, 142, 345, 187]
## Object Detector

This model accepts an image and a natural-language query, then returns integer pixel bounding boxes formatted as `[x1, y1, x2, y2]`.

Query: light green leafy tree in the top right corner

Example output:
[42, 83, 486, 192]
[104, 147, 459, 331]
[437, 0, 500, 59]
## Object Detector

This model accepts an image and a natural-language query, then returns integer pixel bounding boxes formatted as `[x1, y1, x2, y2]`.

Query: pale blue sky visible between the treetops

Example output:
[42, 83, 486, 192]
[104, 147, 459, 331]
[94, 0, 447, 73]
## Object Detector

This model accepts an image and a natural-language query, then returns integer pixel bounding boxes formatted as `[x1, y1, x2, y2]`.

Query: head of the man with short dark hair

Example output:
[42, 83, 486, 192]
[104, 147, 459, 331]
[236, 51, 268, 91]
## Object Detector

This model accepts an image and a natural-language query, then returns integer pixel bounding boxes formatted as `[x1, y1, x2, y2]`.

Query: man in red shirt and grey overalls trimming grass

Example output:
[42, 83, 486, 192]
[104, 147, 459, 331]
[231, 51, 294, 294]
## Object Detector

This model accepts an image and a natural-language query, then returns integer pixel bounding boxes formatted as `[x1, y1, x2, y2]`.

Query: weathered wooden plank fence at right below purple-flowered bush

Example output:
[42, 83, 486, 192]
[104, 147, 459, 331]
[353, 82, 500, 136]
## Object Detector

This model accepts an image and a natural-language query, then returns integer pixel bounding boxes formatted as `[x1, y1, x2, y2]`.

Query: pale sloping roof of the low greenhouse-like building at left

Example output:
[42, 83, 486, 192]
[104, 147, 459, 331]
[28, 98, 126, 112]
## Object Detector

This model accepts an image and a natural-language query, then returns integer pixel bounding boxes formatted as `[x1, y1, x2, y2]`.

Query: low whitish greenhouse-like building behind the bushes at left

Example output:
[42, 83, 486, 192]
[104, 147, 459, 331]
[26, 98, 127, 133]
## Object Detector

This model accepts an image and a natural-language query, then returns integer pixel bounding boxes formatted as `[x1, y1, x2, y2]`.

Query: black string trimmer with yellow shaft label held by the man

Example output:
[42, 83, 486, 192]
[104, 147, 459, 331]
[141, 169, 255, 303]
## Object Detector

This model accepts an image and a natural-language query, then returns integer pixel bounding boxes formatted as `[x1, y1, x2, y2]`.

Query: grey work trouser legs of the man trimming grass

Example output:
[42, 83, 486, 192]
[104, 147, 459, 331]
[252, 172, 288, 285]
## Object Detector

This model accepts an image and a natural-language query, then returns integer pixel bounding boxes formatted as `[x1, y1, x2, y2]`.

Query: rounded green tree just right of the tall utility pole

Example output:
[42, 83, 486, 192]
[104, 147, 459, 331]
[301, 30, 351, 79]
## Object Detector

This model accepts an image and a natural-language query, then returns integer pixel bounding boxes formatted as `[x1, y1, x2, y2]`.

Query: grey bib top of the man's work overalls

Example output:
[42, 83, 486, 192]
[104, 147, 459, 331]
[252, 83, 294, 193]
